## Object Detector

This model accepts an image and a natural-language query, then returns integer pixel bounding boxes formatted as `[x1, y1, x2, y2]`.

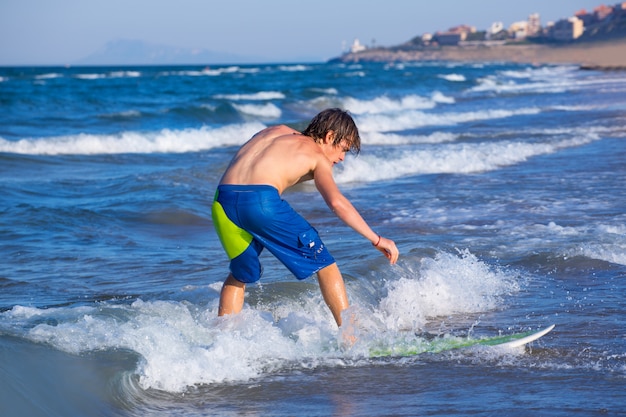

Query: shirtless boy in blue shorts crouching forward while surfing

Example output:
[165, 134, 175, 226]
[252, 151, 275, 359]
[212, 109, 399, 326]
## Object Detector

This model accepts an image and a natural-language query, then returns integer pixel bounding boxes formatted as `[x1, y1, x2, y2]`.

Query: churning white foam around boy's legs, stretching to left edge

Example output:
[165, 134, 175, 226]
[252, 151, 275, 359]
[0, 288, 346, 392]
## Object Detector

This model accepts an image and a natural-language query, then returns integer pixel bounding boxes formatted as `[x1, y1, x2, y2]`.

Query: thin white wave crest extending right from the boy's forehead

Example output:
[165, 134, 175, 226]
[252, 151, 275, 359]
[358, 107, 541, 132]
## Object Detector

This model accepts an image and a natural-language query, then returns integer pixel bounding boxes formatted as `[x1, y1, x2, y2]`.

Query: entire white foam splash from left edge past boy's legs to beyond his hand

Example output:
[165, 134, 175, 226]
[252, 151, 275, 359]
[0, 251, 519, 392]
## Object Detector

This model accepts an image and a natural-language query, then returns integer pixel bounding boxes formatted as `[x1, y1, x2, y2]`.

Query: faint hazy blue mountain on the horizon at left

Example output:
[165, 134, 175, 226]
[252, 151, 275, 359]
[75, 39, 263, 65]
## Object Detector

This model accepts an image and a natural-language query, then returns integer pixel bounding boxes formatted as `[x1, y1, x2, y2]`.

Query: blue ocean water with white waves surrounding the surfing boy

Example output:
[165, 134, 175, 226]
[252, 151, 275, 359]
[0, 62, 626, 417]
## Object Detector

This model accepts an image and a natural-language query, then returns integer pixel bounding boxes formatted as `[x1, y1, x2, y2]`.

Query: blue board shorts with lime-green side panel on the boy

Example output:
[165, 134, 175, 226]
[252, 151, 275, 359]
[211, 185, 335, 283]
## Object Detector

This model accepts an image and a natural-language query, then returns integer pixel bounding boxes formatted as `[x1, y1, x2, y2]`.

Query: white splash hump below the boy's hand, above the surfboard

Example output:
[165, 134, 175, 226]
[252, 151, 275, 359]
[377, 250, 519, 330]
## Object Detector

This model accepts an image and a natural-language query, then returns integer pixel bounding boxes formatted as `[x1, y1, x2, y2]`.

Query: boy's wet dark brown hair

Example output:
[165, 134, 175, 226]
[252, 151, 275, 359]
[302, 108, 361, 154]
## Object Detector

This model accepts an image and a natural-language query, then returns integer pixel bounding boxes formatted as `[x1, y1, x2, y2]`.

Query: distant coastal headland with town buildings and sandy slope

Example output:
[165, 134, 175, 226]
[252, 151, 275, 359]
[331, 2, 626, 69]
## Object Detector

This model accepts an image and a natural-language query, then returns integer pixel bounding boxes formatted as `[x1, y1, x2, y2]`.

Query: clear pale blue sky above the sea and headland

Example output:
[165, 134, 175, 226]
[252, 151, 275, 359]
[0, 0, 604, 65]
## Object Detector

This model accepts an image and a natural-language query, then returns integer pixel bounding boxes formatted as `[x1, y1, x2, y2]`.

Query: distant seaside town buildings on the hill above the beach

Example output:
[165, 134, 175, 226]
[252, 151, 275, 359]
[350, 2, 626, 54]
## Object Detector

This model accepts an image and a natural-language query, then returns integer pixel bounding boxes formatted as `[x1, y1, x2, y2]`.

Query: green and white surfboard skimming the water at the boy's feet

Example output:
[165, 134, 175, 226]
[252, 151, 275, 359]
[370, 324, 555, 358]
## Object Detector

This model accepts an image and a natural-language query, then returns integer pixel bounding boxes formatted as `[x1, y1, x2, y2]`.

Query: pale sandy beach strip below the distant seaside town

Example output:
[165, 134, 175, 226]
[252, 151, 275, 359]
[333, 39, 626, 70]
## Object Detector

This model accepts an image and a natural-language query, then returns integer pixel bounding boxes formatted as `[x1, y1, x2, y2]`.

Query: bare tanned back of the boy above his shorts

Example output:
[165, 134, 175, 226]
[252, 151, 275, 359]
[220, 125, 331, 193]
